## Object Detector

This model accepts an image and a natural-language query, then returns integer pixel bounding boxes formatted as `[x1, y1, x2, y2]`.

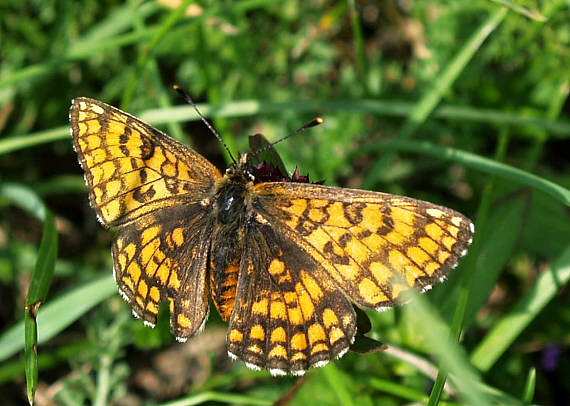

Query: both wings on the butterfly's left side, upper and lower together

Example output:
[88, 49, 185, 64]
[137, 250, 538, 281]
[70, 97, 221, 341]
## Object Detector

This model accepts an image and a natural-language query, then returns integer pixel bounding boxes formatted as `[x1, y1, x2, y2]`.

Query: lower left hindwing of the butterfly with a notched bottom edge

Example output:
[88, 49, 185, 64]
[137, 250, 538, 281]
[112, 203, 213, 341]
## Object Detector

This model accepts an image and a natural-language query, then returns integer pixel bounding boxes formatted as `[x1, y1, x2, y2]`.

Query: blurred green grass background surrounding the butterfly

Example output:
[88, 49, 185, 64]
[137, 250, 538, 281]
[0, 0, 570, 405]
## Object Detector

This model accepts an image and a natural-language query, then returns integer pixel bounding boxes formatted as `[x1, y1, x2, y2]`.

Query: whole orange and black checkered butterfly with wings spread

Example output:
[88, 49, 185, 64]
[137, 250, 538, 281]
[70, 97, 474, 375]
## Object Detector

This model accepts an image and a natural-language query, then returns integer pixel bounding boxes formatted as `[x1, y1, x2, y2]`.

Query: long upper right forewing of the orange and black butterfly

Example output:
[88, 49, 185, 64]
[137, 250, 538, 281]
[253, 183, 474, 309]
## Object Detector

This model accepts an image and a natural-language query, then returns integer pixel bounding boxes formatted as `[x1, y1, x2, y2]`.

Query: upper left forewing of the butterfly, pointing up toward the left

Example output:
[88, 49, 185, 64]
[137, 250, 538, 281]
[69, 97, 221, 226]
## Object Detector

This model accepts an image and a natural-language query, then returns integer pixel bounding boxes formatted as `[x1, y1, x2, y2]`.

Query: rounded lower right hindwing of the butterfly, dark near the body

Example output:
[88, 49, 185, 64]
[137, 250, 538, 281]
[225, 222, 356, 375]
